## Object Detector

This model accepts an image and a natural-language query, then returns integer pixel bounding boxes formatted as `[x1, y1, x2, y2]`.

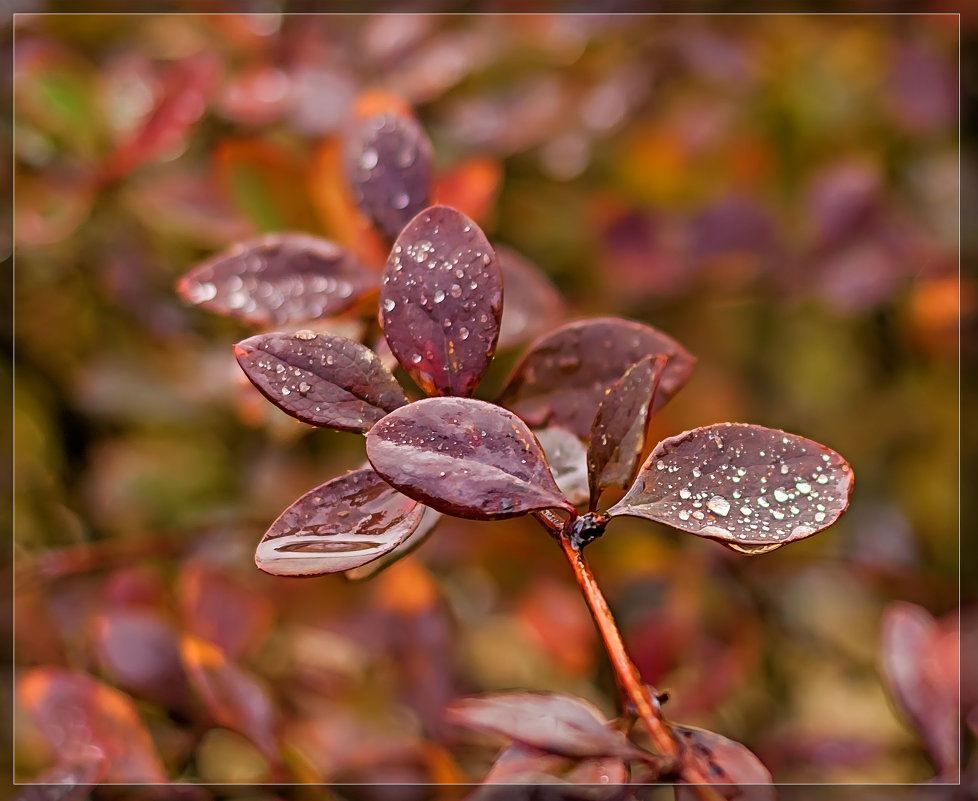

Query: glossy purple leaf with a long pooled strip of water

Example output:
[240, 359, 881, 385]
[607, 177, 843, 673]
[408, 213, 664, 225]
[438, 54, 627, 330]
[255, 467, 425, 576]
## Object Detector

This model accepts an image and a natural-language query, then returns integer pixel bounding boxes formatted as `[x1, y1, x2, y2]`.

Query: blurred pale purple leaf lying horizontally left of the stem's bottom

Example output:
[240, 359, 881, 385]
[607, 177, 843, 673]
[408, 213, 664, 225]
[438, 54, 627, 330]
[446, 693, 643, 758]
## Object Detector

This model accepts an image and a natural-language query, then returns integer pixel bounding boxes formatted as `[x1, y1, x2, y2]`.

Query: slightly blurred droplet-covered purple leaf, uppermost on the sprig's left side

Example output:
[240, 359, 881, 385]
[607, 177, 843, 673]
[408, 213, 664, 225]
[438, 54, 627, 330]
[177, 233, 377, 326]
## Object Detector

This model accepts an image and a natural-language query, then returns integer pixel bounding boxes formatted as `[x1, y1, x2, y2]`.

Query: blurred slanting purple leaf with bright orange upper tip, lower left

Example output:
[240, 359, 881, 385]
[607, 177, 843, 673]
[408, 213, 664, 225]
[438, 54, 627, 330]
[180, 636, 278, 762]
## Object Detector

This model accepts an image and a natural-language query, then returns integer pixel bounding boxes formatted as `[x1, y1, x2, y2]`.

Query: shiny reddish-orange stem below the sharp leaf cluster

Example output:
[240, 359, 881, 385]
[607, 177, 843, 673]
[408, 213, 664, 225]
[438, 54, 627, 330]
[535, 512, 710, 784]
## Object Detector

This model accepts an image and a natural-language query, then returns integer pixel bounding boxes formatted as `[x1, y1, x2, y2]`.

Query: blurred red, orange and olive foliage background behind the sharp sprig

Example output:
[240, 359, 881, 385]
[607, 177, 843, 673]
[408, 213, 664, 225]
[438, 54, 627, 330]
[0, 14, 978, 798]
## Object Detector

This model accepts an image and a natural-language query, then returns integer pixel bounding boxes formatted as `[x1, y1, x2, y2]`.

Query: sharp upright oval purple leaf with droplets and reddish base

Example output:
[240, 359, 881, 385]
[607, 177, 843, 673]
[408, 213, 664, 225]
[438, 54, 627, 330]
[380, 206, 503, 397]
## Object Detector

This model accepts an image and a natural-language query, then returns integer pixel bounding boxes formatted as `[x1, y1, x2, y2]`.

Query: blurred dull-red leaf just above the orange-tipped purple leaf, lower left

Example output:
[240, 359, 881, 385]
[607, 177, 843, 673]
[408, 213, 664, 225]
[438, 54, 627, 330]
[177, 561, 274, 658]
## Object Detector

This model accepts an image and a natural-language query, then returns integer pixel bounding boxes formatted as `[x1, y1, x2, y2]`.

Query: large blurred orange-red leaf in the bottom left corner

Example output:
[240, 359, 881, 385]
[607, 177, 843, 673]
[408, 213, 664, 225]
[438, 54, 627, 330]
[17, 667, 166, 784]
